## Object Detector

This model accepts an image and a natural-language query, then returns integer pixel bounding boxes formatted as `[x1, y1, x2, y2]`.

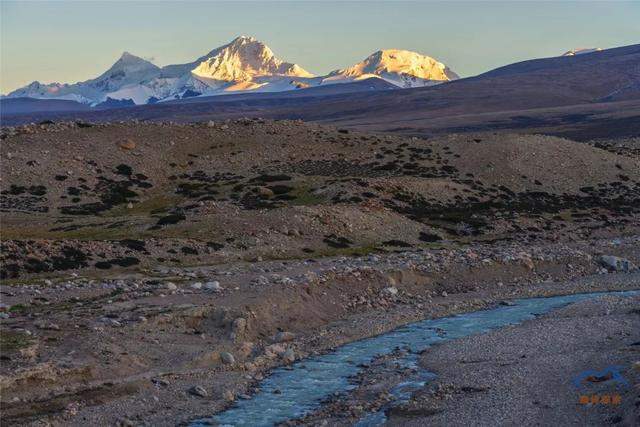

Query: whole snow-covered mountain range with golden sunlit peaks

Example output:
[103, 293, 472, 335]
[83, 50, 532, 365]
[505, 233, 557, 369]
[2, 36, 458, 106]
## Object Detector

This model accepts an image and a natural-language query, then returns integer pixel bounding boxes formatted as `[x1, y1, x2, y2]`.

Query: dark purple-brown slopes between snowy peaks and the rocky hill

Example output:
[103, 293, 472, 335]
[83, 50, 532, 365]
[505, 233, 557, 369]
[0, 45, 640, 140]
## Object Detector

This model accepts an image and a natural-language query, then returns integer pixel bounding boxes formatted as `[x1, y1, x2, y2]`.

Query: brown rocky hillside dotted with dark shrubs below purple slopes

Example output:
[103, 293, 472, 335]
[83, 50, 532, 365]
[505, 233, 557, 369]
[1, 119, 640, 278]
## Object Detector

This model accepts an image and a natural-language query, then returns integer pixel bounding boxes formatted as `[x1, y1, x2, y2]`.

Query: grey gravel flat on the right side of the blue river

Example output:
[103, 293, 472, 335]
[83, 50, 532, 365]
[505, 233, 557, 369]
[288, 273, 640, 426]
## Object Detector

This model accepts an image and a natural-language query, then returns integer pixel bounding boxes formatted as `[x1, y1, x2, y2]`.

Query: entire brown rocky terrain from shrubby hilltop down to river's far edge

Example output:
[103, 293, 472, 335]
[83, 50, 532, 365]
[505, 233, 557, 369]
[0, 119, 640, 425]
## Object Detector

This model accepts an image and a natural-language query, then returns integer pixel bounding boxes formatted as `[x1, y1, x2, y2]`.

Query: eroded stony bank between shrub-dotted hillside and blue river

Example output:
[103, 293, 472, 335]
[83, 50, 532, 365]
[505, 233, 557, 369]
[0, 237, 638, 425]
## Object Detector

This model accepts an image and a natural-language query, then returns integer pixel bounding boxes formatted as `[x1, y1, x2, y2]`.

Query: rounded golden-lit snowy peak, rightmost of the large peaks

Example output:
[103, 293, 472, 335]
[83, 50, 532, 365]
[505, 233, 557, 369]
[323, 49, 458, 87]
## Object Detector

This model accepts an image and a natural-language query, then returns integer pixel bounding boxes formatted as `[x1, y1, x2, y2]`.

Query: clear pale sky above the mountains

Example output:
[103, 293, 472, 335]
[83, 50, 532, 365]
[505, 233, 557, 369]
[0, 0, 640, 93]
